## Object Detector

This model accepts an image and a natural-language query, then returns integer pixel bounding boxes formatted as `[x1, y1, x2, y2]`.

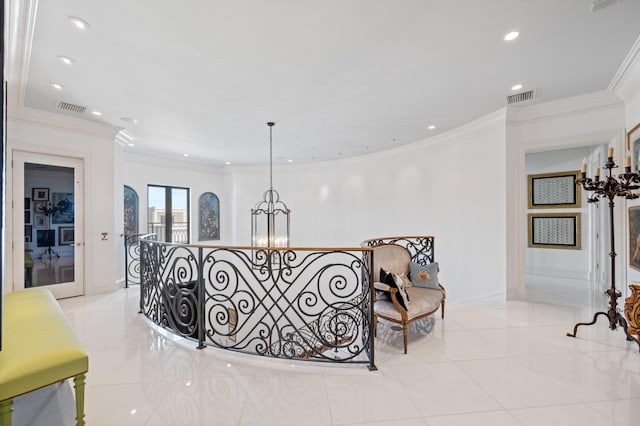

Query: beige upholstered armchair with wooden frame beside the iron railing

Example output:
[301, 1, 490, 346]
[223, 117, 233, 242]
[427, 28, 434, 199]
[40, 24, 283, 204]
[372, 244, 446, 354]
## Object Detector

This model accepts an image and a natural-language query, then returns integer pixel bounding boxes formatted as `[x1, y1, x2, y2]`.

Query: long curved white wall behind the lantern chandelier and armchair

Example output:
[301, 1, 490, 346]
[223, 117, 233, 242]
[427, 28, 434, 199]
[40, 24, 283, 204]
[229, 111, 506, 301]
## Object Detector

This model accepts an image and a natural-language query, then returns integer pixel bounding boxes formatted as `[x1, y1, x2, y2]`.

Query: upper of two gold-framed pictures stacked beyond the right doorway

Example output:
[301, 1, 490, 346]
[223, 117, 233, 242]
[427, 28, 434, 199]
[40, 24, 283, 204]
[527, 170, 581, 209]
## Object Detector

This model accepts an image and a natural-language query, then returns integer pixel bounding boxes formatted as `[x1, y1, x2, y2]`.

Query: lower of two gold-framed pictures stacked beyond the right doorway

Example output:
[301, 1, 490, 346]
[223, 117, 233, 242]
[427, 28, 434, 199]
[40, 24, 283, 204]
[528, 213, 582, 250]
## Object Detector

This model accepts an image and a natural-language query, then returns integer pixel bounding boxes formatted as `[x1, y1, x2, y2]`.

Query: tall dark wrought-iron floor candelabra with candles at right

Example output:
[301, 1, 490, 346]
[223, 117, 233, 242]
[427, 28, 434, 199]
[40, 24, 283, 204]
[567, 154, 640, 349]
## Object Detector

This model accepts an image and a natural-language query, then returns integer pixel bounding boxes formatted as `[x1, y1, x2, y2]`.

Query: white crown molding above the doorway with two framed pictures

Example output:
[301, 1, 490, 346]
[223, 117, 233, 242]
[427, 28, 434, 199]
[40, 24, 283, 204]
[507, 90, 624, 125]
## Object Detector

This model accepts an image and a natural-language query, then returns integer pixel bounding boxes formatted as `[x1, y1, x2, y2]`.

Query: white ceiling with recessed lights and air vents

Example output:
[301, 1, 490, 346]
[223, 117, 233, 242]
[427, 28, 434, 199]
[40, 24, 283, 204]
[14, 0, 640, 165]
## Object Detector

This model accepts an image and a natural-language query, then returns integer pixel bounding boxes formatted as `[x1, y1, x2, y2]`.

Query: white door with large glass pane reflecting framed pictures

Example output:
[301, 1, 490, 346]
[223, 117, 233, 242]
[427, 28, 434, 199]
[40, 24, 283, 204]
[12, 151, 84, 299]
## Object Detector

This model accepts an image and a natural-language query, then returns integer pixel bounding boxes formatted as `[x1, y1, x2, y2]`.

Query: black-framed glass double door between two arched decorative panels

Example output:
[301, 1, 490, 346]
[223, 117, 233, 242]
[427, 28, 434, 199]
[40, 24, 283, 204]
[147, 185, 190, 244]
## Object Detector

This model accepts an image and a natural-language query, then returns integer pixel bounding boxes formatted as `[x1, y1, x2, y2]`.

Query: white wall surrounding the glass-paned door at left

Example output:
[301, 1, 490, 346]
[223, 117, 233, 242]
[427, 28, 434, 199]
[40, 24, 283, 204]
[5, 109, 120, 294]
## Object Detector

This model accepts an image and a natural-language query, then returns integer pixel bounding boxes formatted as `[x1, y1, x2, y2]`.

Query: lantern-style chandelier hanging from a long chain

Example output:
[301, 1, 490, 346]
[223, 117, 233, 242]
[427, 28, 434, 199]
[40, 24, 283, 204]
[251, 122, 291, 248]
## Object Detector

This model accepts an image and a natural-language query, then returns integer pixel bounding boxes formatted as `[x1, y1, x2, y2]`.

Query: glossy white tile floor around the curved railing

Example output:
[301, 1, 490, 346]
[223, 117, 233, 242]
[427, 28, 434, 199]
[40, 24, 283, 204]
[8, 287, 640, 426]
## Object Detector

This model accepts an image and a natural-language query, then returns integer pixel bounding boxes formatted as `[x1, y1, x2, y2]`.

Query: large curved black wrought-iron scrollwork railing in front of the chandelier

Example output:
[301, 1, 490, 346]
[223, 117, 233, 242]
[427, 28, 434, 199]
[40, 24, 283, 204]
[140, 239, 375, 369]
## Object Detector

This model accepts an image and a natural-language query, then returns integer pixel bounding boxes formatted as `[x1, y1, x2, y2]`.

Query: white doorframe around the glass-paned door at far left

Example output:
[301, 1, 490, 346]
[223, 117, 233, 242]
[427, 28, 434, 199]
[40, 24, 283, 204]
[10, 151, 87, 298]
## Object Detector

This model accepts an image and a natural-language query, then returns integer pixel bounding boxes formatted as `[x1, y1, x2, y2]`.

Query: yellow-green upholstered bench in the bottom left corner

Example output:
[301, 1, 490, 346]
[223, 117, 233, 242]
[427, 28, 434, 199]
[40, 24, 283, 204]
[0, 288, 89, 426]
